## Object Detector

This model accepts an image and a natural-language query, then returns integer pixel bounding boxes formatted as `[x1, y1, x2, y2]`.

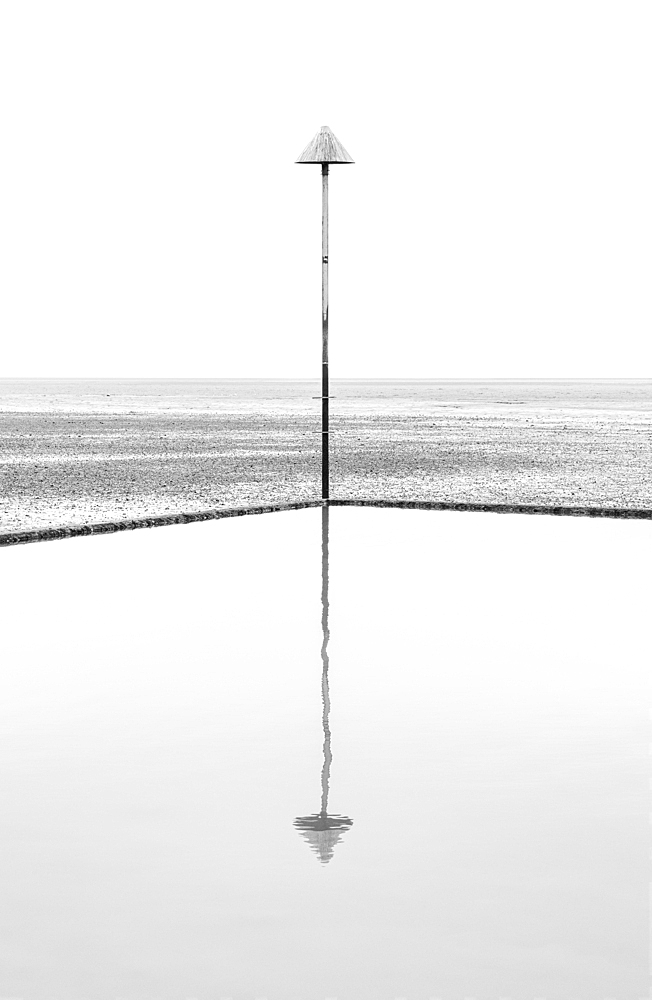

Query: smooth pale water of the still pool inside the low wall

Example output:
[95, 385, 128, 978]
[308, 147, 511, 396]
[0, 508, 652, 1000]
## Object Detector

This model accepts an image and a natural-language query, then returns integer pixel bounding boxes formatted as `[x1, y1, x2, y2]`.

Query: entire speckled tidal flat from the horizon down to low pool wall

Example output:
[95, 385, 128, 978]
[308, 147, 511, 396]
[0, 381, 652, 532]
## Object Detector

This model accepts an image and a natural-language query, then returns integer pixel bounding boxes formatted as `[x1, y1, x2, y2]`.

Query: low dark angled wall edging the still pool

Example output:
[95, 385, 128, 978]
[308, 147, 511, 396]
[0, 498, 652, 546]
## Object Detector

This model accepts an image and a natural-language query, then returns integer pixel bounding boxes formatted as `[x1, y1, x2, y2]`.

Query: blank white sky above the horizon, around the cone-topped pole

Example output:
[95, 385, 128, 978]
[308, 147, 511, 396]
[0, 0, 652, 378]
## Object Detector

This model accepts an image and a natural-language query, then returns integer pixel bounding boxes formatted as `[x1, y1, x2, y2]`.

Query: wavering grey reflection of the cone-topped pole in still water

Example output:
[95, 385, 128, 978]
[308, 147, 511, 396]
[294, 506, 353, 864]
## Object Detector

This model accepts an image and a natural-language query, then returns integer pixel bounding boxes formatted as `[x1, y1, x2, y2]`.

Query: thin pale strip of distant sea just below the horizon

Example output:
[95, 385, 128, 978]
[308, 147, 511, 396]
[0, 379, 652, 414]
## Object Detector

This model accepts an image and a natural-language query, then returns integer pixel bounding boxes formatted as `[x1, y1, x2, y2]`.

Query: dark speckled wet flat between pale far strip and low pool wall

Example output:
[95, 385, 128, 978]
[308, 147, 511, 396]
[0, 403, 652, 532]
